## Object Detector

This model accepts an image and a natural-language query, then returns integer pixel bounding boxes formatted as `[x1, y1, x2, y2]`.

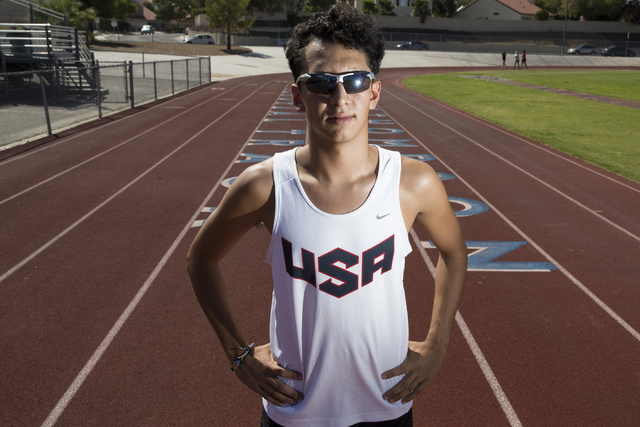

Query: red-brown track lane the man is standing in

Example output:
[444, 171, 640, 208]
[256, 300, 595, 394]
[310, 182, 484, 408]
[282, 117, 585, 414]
[43, 83, 507, 426]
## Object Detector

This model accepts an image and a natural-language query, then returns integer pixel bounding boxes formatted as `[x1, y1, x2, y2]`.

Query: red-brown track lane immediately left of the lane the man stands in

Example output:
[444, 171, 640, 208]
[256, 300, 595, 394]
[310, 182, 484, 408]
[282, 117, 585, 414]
[0, 77, 288, 423]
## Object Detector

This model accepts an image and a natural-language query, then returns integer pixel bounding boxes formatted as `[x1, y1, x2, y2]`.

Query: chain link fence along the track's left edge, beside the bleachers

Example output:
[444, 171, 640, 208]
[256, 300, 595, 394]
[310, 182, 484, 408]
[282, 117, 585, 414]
[0, 57, 211, 149]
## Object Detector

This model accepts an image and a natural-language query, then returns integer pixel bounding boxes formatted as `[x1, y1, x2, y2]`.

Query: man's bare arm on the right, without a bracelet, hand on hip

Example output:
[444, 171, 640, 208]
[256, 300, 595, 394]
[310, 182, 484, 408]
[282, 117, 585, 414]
[382, 159, 467, 403]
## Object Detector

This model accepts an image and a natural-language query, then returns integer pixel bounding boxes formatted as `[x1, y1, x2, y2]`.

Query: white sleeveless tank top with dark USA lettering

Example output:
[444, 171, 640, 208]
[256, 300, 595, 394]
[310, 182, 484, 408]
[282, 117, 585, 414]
[263, 147, 411, 427]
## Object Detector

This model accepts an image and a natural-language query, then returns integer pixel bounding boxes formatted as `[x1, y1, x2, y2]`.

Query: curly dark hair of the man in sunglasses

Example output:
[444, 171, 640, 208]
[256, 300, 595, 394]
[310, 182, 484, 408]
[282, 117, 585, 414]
[284, 3, 384, 80]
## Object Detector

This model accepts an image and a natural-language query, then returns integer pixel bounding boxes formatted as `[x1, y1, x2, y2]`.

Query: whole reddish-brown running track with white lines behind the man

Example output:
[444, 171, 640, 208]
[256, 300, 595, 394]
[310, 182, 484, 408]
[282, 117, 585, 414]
[0, 69, 640, 427]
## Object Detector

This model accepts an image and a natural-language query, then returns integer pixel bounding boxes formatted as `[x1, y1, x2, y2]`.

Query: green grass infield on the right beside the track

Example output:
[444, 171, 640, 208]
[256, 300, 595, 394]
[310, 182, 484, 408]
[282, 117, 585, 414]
[403, 70, 640, 182]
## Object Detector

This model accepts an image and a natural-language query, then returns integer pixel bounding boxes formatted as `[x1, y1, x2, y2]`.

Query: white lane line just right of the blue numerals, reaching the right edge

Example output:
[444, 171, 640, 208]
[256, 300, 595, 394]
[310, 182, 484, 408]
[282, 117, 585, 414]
[376, 103, 640, 341]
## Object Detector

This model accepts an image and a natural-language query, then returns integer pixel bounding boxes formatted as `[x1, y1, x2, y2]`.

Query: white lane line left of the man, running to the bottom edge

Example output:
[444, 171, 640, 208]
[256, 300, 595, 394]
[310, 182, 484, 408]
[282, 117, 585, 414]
[42, 83, 288, 427]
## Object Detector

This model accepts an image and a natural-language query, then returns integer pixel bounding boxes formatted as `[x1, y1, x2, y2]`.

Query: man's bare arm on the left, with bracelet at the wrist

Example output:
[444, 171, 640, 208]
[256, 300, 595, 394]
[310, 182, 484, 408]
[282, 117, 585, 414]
[187, 161, 302, 406]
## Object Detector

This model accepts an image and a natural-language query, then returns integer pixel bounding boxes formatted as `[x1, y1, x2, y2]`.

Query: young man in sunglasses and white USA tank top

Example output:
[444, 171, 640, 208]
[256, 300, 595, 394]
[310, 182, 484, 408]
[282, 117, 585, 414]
[188, 4, 467, 427]
